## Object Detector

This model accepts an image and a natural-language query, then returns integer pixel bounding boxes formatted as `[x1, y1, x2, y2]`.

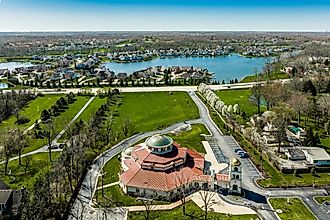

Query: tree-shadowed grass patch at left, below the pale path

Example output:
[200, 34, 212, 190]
[1, 152, 60, 189]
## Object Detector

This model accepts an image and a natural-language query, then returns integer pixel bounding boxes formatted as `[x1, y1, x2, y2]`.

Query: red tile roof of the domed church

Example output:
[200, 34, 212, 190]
[120, 143, 215, 191]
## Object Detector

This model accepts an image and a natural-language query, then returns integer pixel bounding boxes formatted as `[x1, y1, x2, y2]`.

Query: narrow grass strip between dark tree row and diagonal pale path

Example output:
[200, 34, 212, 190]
[23, 96, 89, 153]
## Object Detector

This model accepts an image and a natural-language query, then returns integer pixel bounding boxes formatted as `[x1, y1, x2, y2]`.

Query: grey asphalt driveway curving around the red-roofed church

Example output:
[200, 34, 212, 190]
[69, 91, 329, 220]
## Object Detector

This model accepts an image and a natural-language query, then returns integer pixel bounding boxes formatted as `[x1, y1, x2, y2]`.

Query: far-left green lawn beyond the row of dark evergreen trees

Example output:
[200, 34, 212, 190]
[0, 95, 62, 132]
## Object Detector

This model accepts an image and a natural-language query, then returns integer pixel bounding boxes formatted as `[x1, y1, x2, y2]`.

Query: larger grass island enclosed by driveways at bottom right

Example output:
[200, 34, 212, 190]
[269, 198, 316, 220]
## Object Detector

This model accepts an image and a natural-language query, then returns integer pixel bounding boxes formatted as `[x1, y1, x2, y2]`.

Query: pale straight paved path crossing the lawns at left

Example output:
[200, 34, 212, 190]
[9, 96, 95, 161]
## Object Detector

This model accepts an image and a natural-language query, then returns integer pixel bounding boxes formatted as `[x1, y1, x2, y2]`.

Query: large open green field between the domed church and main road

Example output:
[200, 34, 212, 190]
[115, 92, 199, 132]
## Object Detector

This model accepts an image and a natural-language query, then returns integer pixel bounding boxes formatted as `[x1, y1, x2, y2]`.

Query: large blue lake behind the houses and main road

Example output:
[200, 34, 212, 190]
[104, 54, 272, 81]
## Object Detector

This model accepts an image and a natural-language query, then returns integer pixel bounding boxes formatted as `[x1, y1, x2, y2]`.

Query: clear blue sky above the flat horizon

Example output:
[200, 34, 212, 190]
[0, 0, 330, 32]
